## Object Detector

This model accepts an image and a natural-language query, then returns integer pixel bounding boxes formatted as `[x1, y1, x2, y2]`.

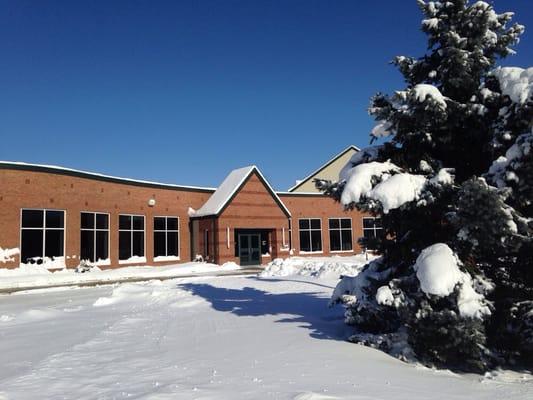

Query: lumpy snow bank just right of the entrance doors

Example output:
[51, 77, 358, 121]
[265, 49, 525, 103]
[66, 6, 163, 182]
[259, 254, 375, 279]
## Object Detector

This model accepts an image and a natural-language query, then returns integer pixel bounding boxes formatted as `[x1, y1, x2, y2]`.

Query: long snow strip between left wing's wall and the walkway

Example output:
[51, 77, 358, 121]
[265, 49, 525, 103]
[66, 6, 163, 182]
[0, 262, 240, 289]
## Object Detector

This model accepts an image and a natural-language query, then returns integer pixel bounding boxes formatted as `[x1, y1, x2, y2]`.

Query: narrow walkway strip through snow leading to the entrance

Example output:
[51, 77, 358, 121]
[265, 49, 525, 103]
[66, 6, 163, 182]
[0, 266, 264, 295]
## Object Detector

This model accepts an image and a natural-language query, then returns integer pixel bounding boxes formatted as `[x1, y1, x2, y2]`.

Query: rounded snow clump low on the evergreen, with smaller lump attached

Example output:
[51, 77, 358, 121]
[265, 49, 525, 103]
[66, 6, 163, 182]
[413, 243, 490, 318]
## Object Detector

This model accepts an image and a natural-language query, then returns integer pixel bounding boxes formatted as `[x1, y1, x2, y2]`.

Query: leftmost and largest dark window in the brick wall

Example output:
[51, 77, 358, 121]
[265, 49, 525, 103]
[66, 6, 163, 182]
[20, 209, 65, 266]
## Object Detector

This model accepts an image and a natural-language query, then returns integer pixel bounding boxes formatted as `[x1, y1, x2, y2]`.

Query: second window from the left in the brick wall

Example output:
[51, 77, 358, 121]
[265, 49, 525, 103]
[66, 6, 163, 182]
[80, 212, 109, 264]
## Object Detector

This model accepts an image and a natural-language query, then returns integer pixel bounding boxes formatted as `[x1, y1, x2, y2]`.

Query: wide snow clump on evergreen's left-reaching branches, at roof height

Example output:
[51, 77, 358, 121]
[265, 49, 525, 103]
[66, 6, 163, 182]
[339, 160, 454, 214]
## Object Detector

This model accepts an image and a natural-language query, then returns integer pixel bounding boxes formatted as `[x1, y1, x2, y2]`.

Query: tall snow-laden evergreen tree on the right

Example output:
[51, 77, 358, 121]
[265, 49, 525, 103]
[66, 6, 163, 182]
[316, 0, 533, 371]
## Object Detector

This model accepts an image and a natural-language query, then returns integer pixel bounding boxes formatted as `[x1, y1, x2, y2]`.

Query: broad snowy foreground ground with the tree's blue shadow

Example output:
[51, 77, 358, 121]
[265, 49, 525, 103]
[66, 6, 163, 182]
[0, 258, 533, 400]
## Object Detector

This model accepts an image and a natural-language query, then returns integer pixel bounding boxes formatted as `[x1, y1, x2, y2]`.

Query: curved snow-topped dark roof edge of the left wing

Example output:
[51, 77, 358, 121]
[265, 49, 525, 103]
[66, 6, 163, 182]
[0, 161, 216, 192]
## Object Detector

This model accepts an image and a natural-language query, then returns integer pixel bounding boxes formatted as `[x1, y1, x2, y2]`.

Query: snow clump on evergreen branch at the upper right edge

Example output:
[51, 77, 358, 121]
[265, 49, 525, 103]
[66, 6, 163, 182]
[491, 67, 533, 104]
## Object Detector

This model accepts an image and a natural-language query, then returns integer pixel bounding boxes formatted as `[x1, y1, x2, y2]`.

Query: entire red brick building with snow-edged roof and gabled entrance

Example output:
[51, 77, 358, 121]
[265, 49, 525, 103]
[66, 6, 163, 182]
[0, 146, 377, 269]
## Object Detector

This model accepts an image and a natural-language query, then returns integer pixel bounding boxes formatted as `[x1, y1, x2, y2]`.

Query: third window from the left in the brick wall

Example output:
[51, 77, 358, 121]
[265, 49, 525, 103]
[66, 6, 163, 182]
[118, 215, 146, 261]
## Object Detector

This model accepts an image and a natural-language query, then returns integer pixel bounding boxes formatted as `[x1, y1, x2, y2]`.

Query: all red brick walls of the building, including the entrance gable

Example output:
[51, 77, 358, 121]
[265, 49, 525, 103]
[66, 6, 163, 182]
[0, 169, 370, 267]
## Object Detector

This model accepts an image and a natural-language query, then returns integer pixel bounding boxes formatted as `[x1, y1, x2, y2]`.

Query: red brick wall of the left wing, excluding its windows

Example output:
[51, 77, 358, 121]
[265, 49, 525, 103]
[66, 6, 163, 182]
[0, 169, 211, 267]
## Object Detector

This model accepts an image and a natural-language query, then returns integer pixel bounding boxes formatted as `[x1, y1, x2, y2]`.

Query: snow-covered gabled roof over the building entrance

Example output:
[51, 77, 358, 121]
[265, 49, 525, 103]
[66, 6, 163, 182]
[190, 165, 291, 218]
